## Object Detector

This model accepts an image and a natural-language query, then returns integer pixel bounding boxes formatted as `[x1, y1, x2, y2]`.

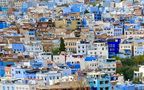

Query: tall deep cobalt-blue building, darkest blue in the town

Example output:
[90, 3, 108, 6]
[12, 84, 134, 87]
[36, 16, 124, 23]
[107, 38, 121, 58]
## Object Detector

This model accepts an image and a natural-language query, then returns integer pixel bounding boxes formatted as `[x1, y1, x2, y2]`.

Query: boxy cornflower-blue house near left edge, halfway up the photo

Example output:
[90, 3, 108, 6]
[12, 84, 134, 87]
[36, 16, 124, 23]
[12, 43, 25, 53]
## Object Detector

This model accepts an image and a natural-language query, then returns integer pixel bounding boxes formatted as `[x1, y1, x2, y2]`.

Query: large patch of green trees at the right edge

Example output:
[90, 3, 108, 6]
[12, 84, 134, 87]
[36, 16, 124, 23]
[115, 55, 144, 82]
